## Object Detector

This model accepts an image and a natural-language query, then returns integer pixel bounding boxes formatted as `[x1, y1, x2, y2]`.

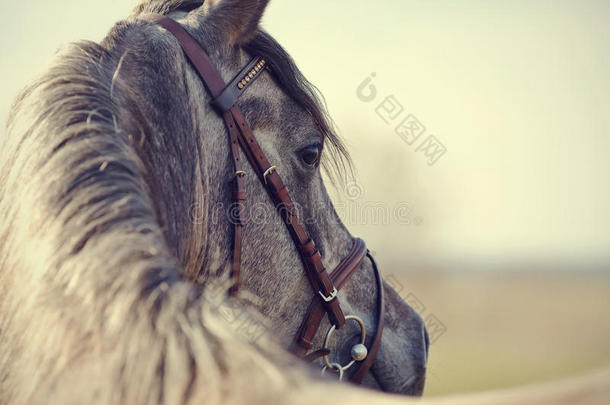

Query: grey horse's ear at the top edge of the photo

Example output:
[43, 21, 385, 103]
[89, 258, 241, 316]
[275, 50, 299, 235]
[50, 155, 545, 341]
[203, 0, 269, 45]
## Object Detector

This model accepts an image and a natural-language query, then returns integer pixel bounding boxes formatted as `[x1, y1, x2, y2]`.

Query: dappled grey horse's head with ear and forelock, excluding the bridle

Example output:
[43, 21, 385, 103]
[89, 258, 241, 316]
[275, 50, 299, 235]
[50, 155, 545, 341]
[128, 0, 428, 394]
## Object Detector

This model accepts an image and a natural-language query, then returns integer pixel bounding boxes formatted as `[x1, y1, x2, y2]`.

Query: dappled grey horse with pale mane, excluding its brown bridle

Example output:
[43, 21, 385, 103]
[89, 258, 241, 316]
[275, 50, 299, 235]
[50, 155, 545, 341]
[0, 0, 429, 404]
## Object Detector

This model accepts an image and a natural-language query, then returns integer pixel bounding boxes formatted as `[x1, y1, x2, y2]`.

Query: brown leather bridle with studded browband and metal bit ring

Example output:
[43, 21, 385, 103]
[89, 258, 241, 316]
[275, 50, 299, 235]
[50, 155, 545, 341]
[153, 15, 385, 384]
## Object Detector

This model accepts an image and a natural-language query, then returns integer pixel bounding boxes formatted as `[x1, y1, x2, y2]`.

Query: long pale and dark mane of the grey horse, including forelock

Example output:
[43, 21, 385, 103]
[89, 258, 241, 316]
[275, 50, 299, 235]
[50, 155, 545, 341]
[0, 0, 347, 404]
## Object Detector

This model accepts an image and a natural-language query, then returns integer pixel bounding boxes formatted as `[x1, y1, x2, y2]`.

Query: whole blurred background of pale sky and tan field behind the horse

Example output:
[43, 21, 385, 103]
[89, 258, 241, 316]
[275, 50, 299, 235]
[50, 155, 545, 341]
[0, 0, 610, 396]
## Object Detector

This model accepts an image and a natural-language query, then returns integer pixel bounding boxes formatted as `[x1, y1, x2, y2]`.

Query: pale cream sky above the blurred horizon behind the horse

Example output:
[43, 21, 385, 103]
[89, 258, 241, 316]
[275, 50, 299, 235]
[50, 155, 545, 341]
[0, 0, 610, 268]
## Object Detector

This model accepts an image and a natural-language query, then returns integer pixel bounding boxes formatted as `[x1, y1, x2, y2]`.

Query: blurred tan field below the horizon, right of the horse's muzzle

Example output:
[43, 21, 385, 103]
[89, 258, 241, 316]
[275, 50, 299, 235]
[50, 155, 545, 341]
[384, 267, 610, 396]
